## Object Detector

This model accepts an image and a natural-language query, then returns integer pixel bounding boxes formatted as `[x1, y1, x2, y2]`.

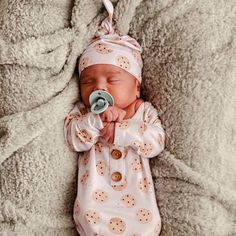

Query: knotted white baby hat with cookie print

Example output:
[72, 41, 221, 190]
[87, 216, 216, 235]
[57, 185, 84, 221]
[79, 0, 143, 83]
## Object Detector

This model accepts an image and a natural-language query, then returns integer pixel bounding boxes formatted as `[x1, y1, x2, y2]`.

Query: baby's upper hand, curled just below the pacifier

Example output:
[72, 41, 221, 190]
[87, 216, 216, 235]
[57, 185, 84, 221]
[100, 106, 126, 122]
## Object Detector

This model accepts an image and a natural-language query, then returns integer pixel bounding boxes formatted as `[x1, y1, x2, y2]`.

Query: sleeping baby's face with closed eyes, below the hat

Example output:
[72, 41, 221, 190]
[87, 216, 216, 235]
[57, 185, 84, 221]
[80, 64, 140, 109]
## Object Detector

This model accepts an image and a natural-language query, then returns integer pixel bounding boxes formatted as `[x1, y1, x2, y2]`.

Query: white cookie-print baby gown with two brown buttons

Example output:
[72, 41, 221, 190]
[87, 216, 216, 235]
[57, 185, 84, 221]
[64, 102, 165, 236]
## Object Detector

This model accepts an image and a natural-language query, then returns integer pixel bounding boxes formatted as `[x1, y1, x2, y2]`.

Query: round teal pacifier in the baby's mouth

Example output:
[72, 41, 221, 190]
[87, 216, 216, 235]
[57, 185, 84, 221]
[89, 90, 114, 114]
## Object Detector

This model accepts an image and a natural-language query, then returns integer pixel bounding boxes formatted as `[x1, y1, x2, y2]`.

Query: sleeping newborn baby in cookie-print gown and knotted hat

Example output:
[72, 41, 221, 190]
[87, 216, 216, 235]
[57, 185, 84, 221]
[64, 0, 165, 236]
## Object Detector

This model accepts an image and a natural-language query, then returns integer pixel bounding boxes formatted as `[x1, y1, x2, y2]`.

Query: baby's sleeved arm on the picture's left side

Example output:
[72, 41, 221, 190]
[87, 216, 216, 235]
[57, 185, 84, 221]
[64, 103, 104, 152]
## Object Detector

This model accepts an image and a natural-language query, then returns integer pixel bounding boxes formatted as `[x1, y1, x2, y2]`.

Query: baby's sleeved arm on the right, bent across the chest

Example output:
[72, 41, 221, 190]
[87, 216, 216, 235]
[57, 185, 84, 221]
[114, 102, 165, 157]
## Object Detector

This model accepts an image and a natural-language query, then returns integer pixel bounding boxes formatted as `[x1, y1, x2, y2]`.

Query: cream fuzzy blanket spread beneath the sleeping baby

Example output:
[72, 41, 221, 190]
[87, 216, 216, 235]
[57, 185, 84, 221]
[0, 0, 236, 236]
